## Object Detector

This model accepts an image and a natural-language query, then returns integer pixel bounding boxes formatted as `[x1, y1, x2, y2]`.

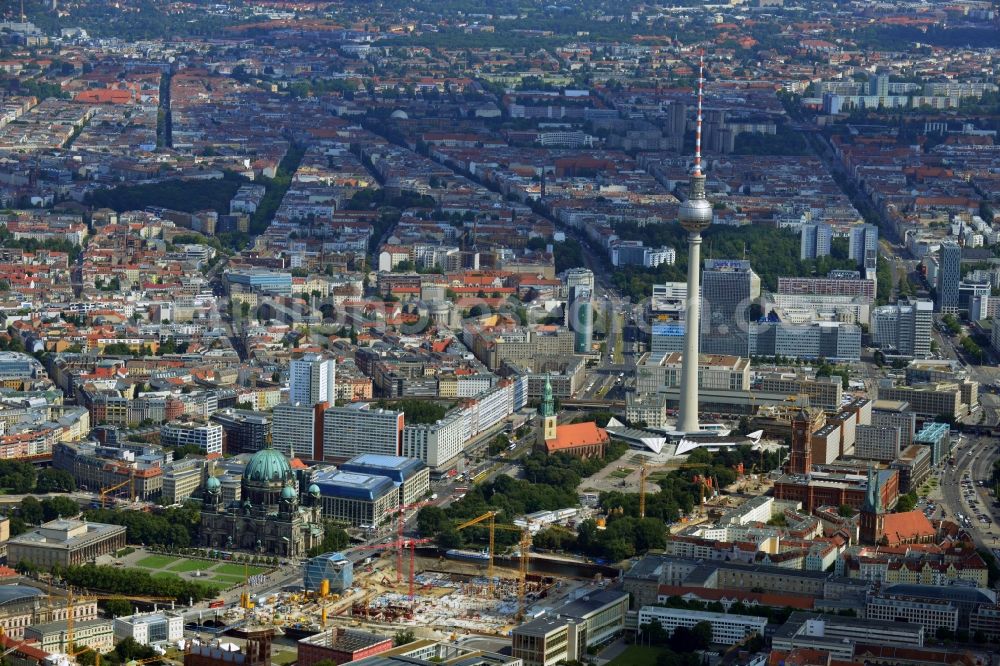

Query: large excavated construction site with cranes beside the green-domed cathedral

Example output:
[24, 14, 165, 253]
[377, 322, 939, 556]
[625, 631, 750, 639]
[191, 504, 593, 639]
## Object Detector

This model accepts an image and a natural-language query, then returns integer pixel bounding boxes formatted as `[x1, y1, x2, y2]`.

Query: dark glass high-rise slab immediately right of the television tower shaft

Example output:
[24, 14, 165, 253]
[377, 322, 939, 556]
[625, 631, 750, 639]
[701, 260, 760, 357]
